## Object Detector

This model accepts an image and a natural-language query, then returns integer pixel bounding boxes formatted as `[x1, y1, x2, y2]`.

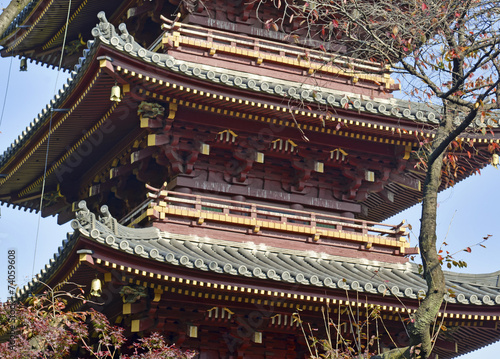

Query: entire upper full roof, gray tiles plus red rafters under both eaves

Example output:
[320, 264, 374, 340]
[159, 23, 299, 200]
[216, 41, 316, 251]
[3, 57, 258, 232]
[0, 13, 500, 220]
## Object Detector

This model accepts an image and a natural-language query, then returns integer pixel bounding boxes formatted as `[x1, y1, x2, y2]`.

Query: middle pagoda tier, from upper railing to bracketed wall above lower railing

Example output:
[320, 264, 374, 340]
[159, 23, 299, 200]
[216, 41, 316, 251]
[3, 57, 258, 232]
[0, 9, 499, 229]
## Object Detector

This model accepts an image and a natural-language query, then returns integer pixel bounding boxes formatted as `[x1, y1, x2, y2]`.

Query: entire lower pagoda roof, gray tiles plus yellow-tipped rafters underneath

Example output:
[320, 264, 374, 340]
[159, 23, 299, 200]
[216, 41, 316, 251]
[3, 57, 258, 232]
[17, 201, 500, 358]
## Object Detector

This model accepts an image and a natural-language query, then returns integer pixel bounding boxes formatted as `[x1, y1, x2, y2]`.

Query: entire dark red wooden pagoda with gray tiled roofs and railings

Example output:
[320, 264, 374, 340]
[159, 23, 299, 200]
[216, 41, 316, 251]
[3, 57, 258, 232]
[0, 0, 500, 359]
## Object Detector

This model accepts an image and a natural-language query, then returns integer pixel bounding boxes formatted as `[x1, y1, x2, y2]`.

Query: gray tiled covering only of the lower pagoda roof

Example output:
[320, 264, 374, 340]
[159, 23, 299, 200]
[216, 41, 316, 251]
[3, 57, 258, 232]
[20, 201, 500, 306]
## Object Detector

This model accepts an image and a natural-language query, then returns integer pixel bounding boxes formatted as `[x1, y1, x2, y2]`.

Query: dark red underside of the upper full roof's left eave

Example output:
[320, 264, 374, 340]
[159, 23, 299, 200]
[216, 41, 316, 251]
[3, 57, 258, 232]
[0, 39, 127, 209]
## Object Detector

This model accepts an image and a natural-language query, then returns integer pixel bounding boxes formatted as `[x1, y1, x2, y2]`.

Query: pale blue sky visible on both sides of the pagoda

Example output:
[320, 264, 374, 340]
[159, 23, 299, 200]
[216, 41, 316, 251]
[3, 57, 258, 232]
[0, 54, 500, 359]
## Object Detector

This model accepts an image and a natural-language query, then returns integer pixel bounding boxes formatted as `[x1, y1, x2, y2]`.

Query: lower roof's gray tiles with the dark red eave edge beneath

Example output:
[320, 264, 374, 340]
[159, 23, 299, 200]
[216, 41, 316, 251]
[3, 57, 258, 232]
[21, 202, 500, 314]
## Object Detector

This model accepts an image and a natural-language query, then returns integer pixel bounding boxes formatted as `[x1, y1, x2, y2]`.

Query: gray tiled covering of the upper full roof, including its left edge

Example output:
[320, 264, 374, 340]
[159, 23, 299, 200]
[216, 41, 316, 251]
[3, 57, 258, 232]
[4, 12, 500, 172]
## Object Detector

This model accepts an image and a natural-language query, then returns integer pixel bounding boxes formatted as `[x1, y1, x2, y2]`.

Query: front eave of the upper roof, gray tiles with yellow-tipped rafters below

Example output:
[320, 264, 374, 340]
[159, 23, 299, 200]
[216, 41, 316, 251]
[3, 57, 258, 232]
[94, 20, 500, 143]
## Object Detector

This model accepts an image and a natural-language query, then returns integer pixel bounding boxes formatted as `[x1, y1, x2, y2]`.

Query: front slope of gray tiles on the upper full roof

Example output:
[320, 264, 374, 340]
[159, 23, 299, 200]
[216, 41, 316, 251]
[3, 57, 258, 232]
[92, 12, 444, 125]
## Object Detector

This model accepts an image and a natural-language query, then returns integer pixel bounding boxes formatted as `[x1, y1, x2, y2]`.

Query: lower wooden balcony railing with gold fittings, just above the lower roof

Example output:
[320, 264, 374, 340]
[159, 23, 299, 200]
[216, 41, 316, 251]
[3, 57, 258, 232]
[147, 188, 414, 255]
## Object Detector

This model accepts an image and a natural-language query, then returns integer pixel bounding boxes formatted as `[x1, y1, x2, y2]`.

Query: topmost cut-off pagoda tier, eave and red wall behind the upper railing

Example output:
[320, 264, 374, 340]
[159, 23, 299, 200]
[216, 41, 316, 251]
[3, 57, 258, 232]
[0, 0, 368, 69]
